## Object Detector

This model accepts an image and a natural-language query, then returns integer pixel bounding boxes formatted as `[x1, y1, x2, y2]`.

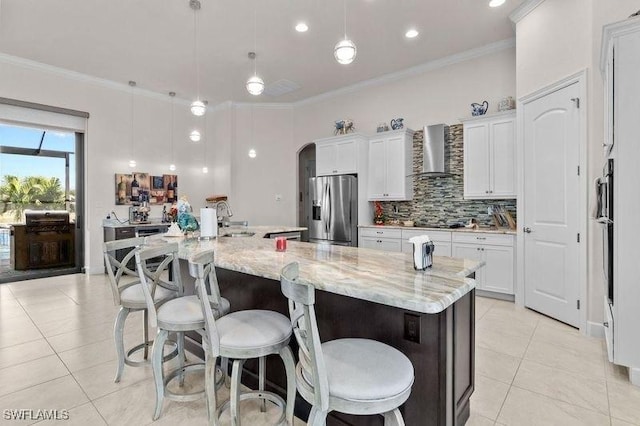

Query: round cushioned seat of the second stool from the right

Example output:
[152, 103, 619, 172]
[216, 309, 291, 353]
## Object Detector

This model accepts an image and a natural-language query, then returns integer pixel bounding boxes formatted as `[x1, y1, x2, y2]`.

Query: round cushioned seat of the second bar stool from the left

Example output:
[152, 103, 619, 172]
[157, 295, 231, 331]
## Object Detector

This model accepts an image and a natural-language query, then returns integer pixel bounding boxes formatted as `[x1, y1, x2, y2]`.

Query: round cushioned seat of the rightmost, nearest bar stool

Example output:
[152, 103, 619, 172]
[303, 339, 414, 401]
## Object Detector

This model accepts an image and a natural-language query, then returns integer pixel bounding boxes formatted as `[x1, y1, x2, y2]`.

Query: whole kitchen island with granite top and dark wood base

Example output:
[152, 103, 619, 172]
[158, 227, 483, 425]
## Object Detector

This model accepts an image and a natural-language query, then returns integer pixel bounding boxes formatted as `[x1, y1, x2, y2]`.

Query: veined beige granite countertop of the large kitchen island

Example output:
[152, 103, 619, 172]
[150, 226, 484, 314]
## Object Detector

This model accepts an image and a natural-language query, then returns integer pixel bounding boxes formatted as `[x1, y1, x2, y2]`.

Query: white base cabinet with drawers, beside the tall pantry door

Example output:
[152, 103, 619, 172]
[452, 232, 515, 294]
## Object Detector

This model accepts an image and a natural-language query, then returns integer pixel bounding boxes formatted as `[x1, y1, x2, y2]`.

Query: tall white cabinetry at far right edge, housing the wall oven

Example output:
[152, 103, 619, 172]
[600, 17, 640, 386]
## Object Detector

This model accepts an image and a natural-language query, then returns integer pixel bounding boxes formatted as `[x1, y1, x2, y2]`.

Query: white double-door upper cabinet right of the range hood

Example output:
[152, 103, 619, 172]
[463, 111, 517, 199]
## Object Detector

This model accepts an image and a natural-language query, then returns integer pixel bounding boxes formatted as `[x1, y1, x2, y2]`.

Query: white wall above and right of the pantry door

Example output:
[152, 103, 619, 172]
[516, 0, 640, 323]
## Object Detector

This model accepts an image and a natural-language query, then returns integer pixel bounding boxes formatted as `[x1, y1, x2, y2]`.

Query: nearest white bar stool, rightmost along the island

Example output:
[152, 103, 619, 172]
[280, 263, 414, 426]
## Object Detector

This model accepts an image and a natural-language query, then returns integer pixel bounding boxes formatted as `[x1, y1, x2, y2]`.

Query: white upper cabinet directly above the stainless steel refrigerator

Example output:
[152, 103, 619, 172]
[314, 133, 366, 176]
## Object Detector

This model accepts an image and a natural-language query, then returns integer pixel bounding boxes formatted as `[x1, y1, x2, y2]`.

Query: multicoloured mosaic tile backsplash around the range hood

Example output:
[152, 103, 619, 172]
[381, 124, 516, 227]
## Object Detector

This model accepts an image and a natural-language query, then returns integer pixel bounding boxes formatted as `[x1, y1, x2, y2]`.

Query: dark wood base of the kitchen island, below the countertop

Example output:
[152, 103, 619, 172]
[181, 261, 475, 426]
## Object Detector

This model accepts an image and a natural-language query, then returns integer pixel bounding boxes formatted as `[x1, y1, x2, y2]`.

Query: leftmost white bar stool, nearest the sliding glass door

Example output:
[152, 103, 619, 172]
[102, 237, 178, 383]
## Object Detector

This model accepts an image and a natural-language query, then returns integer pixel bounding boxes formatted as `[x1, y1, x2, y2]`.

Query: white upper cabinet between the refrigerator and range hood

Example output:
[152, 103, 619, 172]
[368, 129, 413, 201]
